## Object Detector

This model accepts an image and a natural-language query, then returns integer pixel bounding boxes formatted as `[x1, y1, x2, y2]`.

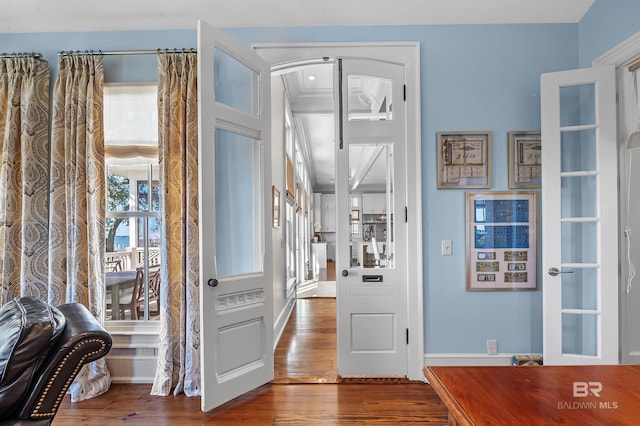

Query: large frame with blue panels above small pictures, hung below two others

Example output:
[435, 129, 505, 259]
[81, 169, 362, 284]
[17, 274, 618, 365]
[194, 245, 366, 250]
[466, 191, 538, 290]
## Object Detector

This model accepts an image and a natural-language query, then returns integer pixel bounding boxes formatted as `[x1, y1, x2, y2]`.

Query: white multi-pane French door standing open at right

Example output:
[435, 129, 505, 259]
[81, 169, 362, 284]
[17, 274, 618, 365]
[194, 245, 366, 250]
[540, 67, 618, 365]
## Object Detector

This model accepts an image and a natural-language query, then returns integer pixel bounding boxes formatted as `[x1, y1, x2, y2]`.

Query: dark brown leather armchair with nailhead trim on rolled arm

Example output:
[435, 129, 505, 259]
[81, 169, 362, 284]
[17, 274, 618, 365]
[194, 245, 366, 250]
[0, 297, 112, 426]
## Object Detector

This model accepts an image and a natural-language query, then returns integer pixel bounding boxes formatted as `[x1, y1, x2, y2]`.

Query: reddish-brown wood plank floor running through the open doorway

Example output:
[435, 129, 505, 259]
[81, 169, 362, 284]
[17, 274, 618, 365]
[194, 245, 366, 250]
[53, 298, 447, 426]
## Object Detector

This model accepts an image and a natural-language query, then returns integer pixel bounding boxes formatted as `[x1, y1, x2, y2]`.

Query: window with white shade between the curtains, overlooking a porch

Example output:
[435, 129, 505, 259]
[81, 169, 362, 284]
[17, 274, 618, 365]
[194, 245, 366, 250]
[104, 84, 162, 321]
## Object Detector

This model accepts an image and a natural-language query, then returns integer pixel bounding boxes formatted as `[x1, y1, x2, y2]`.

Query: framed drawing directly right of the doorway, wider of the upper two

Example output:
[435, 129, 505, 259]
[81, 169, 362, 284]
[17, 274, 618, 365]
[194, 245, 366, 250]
[438, 131, 491, 189]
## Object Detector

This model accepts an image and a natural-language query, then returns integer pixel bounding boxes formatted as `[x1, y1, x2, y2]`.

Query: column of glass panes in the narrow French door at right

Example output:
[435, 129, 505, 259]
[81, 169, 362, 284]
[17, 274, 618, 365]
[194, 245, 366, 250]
[560, 83, 600, 356]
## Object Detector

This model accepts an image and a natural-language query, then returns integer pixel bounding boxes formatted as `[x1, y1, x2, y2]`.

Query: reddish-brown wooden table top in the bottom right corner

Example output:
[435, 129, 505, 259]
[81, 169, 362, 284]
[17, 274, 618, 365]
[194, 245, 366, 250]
[423, 365, 640, 426]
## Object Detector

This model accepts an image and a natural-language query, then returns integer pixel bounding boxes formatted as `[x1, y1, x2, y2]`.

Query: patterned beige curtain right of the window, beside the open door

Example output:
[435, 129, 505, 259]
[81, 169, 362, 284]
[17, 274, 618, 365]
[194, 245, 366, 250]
[151, 52, 200, 396]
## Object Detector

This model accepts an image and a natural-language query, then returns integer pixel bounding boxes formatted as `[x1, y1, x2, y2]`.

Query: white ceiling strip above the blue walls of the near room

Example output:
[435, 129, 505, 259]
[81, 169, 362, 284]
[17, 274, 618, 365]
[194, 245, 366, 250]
[0, 0, 594, 33]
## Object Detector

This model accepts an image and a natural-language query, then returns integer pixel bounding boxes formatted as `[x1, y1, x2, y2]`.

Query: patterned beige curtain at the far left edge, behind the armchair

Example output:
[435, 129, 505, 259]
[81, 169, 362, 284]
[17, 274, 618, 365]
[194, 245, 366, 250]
[0, 57, 49, 305]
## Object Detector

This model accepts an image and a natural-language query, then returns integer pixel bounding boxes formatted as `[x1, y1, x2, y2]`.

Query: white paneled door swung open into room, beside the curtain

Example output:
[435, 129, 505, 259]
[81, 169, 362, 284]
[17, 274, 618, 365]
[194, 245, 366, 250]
[198, 21, 273, 411]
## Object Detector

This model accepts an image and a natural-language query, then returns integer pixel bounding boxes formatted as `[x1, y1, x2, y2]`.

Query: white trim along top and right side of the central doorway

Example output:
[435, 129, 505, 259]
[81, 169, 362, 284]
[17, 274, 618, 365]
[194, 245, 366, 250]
[252, 42, 424, 380]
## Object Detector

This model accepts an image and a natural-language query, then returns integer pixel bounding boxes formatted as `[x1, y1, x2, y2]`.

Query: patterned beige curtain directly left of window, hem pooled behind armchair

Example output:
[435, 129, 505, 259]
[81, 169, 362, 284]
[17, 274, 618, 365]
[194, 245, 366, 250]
[49, 55, 111, 401]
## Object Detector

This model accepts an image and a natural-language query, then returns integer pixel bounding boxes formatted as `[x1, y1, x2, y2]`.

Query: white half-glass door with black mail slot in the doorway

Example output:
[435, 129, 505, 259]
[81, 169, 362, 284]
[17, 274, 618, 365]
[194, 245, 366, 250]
[336, 59, 408, 377]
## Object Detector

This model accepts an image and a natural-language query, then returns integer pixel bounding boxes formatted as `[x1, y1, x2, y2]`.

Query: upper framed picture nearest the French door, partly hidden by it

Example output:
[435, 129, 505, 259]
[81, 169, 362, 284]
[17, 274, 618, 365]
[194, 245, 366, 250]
[509, 131, 542, 188]
